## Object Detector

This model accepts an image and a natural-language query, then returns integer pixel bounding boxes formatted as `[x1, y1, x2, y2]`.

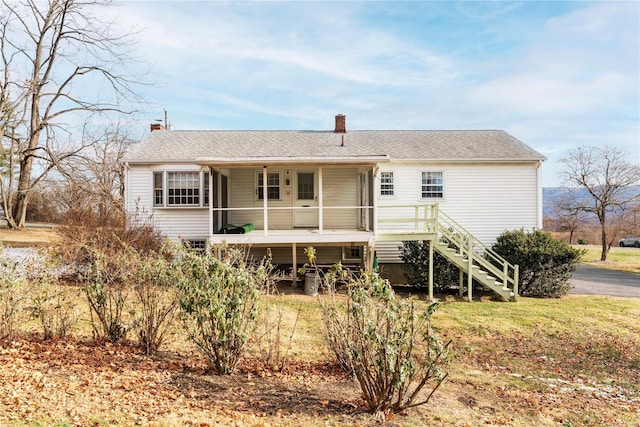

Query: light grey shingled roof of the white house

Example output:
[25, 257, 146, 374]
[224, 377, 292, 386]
[124, 130, 545, 163]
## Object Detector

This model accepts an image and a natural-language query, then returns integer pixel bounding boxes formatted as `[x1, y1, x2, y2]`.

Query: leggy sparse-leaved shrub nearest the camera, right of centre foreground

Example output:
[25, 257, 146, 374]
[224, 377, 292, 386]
[320, 273, 448, 417]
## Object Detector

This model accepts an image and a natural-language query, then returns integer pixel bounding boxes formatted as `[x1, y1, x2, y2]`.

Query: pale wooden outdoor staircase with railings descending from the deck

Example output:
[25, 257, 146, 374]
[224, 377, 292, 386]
[430, 210, 518, 301]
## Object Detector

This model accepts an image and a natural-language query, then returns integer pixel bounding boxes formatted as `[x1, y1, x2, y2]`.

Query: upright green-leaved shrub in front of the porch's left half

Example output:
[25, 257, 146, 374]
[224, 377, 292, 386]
[179, 248, 270, 374]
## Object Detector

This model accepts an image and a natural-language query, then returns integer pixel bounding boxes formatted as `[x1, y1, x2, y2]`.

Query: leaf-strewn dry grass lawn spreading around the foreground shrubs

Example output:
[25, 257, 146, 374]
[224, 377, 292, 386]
[0, 287, 640, 427]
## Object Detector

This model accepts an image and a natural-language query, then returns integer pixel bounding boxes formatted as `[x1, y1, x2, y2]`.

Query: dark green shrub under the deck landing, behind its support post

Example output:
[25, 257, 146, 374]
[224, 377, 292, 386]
[400, 241, 459, 292]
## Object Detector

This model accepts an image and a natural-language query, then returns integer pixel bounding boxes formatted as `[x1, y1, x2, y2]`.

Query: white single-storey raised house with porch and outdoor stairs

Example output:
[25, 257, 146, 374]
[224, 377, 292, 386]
[125, 115, 545, 298]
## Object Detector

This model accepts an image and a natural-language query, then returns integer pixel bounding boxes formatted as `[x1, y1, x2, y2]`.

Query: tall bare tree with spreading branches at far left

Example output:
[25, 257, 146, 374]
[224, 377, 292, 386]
[0, 0, 138, 228]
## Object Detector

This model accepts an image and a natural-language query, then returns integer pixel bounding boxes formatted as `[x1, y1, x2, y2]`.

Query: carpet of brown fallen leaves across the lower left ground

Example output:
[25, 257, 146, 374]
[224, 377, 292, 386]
[0, 339, 364, 426]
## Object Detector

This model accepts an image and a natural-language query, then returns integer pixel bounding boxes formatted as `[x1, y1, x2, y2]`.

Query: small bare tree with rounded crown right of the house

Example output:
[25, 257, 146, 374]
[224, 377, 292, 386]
[561, 146, 640, 261]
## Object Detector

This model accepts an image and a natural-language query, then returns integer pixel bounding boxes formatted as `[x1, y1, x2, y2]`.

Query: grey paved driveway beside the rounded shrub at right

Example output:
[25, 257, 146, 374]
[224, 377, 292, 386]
[569, 264, 640, 298]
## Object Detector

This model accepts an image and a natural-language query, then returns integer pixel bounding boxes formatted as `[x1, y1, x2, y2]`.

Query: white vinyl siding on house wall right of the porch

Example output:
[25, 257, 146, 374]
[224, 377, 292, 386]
[376, 162, 539, 262]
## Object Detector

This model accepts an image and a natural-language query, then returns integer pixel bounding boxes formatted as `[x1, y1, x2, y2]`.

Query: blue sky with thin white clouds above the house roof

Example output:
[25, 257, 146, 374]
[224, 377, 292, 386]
[108, 1, 640, 186]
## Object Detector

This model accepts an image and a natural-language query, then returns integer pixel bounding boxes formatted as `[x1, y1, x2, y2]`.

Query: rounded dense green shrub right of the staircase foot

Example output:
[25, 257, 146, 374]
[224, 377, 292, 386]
[492, 229, 586, 298]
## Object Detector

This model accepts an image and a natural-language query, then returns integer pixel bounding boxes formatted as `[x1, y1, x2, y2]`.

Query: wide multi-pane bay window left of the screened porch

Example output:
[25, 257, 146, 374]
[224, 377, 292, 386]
[153, 171, 209, 207]
